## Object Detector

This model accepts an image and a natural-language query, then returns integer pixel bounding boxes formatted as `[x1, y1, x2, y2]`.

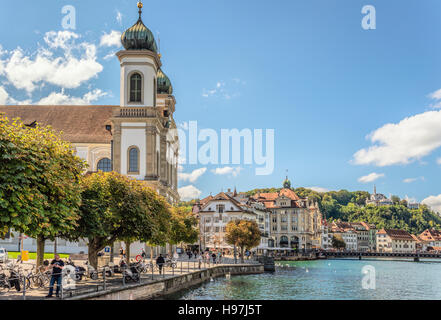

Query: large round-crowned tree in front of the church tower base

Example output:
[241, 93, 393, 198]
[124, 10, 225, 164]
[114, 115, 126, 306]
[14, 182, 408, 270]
[77, 172, 169, 267]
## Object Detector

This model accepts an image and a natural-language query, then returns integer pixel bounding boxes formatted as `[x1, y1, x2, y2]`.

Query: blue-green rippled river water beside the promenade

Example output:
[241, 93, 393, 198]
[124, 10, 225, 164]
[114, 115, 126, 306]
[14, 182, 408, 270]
[168, 260, 441, 300]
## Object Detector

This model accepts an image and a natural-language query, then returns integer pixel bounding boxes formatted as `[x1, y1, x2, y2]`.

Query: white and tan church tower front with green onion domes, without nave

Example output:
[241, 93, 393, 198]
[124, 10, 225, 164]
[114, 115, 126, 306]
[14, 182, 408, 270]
[112, 2, 179, 203]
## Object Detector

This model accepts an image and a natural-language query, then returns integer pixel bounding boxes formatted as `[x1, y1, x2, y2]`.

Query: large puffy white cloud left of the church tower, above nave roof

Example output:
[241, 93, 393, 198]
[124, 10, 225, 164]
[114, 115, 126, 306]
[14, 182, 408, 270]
[0, 31, 103, 93]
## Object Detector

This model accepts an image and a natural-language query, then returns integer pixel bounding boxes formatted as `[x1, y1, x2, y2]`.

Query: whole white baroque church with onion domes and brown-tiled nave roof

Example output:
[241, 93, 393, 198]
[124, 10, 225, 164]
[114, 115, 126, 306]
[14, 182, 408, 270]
[0, 2, 179, 253]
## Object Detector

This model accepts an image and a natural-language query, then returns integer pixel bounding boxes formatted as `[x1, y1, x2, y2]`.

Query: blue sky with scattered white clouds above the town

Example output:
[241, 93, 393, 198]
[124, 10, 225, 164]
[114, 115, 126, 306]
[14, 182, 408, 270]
[0, 0, 441, 211]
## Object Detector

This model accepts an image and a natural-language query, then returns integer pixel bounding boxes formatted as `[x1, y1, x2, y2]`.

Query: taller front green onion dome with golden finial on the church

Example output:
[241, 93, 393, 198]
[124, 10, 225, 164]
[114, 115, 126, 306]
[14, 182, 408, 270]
[121, 2, 158, 53]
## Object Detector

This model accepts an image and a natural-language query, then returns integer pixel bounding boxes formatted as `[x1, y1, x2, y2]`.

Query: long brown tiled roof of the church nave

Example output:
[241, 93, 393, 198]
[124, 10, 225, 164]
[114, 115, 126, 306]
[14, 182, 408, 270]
[0, 105, 114, 144]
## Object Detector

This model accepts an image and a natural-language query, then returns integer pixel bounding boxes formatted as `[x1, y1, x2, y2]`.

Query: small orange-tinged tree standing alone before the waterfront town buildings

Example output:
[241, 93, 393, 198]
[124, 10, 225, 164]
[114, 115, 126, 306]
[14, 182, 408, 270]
[225, 220, 261, 262]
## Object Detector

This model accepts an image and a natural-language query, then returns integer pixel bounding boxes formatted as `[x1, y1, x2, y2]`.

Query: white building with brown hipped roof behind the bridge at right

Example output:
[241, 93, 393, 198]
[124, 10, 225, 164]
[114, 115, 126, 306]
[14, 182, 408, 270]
[377, 229, 416, 253]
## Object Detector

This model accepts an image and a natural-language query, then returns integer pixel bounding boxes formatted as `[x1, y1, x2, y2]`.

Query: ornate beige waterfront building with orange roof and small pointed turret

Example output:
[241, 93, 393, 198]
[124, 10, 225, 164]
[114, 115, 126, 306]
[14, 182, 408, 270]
[252, 177, 322, 251]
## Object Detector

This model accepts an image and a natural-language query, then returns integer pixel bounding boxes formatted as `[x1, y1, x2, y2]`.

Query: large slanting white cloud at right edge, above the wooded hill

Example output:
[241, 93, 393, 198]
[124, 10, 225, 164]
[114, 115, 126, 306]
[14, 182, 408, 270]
[353, 110, 441, 167]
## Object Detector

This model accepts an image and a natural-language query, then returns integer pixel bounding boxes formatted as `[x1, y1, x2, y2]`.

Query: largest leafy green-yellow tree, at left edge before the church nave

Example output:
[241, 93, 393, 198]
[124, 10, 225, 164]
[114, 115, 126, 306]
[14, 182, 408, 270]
[0, 114, 86, 265]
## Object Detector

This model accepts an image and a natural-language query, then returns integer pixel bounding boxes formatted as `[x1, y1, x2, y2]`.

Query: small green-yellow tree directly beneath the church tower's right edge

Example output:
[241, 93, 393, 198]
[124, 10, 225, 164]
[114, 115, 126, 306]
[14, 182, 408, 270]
[168, 207, 199, 256]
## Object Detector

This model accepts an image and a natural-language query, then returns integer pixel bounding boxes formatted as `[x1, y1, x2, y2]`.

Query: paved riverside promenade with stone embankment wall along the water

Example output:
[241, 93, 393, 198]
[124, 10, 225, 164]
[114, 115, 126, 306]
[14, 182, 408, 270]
[0, 258, 264, 301]
